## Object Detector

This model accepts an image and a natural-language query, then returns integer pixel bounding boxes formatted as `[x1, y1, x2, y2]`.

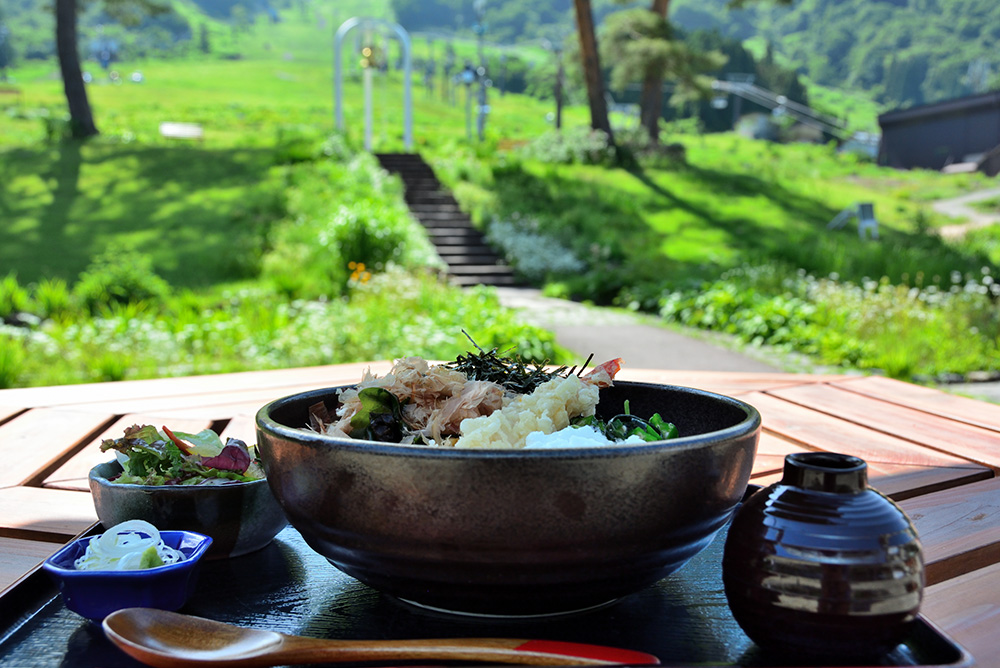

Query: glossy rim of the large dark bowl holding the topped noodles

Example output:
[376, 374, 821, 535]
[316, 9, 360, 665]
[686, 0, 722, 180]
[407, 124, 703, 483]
[255, 381, 761, 459]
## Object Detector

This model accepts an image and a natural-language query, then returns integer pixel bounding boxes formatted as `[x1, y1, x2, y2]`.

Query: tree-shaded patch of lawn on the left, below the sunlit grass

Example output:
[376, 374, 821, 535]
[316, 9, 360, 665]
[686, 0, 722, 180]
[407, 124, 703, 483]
[0, 142, 277, 287]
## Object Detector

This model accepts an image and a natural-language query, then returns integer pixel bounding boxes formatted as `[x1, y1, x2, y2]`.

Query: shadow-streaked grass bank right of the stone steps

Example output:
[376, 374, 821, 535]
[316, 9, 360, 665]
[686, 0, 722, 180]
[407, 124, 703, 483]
[482, 159, 988, 290]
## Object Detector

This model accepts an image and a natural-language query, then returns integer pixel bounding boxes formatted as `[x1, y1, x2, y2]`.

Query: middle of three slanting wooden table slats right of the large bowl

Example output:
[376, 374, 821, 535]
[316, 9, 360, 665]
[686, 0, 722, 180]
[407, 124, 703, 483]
[769, 385, 1000, 469]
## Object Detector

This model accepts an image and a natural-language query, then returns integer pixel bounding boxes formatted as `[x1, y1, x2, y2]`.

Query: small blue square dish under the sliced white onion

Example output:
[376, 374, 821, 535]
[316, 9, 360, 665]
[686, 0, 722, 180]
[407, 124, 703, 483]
[42, 531, 212, 621]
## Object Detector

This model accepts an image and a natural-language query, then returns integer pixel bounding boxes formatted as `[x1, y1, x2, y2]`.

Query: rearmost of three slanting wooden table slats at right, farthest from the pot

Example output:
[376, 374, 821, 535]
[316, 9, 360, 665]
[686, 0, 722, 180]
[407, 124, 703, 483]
[829, 376, 1000, 431]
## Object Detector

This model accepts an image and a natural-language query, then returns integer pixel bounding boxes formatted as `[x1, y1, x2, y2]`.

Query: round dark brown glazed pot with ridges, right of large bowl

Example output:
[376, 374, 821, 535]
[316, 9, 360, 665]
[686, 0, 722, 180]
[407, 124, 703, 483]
[722, 452, 924, 658]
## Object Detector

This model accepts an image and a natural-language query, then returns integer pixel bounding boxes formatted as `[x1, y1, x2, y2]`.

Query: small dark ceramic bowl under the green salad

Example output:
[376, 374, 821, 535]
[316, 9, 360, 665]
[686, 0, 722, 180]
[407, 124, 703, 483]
[90, 461, 288, 559]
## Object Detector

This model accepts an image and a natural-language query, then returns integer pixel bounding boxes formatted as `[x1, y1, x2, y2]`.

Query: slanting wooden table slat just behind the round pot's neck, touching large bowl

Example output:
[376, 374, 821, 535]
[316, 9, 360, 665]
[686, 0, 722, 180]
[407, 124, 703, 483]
[743, 388, 968, 467]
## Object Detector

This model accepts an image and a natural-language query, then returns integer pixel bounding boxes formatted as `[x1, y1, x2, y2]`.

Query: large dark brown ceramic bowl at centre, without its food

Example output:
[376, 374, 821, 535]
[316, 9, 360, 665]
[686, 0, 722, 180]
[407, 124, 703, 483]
[257, 382, 760, 615]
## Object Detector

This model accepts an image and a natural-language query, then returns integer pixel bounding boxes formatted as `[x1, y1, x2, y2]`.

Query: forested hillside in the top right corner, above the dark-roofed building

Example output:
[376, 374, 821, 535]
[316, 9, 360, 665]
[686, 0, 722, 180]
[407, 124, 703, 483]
[673, 0, 1000, 107]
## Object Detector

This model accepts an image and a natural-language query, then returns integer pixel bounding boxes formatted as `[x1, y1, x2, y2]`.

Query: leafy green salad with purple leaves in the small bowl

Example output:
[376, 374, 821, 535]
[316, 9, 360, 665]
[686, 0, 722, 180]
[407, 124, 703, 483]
[101, 425, 264, 485]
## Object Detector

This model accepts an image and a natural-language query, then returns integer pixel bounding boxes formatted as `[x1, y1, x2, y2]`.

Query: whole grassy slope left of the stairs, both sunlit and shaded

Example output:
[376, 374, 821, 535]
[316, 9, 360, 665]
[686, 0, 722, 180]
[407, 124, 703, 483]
[0, 11, 582, 287]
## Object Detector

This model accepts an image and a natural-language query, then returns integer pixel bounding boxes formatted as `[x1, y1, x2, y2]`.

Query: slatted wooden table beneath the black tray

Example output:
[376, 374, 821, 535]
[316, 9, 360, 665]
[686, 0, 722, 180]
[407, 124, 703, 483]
[0, 362, 1000, 665]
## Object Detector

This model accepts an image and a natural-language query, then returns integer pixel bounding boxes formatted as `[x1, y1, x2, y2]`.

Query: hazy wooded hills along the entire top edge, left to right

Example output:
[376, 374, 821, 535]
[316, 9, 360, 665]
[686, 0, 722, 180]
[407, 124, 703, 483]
[0, 0, 1000, 115]
